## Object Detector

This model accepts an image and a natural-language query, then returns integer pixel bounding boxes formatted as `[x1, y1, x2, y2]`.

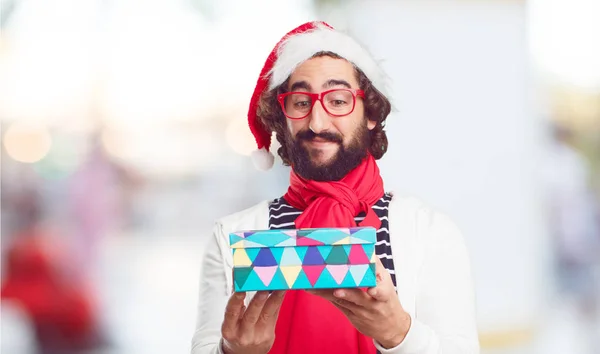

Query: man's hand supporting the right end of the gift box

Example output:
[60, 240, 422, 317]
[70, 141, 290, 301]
[309, 258, 411, 349]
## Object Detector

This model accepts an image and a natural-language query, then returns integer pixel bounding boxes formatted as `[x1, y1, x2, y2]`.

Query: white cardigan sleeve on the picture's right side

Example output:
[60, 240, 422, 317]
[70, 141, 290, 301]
[375, 213, 479, 354]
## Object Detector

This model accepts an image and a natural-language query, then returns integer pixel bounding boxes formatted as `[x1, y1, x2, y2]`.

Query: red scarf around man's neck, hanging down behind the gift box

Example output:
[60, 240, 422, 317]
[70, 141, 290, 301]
[269, 155, 383, 354]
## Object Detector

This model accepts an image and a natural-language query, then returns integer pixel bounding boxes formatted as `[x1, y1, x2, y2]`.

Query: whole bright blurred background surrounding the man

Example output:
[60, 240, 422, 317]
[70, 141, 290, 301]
[0, 0, 600, 354]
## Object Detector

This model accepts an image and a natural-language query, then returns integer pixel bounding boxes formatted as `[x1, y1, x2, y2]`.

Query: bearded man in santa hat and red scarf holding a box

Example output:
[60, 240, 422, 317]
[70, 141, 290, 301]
[192, 22, 479, 354]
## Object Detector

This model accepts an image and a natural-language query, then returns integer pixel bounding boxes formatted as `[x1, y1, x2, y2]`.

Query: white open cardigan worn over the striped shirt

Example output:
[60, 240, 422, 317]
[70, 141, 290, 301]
[192, 197, 479, 354]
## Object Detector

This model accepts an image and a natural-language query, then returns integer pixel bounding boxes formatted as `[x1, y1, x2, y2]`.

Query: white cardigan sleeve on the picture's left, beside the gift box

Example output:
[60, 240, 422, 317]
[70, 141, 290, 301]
[191, 223, 232, 354]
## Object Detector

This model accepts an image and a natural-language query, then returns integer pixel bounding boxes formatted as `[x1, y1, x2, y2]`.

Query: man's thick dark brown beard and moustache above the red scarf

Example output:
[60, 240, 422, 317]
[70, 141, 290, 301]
[286, 122, 371, 181]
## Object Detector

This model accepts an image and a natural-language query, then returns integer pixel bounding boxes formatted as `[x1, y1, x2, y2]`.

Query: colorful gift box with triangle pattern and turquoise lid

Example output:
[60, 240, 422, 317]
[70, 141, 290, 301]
[229, 227, 377, 291]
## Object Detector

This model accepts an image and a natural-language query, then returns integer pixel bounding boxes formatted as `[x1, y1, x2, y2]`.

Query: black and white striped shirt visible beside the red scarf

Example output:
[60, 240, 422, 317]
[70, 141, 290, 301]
[269, 193, 396, 287]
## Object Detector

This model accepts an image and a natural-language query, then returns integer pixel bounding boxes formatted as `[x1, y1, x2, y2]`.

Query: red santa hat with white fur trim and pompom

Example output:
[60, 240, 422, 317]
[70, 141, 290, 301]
[248, 21, 386, 170]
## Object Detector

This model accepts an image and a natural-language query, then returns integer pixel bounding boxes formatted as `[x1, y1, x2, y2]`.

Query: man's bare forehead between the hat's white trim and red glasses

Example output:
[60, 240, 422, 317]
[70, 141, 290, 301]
[288, 56, 358, 89]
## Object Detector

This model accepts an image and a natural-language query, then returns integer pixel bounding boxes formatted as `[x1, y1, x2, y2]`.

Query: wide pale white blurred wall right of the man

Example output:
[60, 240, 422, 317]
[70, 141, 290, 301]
[332, 1, 549, 342]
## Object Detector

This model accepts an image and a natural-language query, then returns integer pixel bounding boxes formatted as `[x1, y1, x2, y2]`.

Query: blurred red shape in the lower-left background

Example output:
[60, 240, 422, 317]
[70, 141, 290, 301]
[0, 229, 97, 352]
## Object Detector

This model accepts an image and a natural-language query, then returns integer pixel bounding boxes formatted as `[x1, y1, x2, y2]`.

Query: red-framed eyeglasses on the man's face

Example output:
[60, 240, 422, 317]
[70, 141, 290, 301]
[277, 89, 365, 119]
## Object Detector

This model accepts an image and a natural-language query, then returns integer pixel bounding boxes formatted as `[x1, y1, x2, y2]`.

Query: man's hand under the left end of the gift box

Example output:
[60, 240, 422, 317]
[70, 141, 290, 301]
[221, 291, 285, 354]
